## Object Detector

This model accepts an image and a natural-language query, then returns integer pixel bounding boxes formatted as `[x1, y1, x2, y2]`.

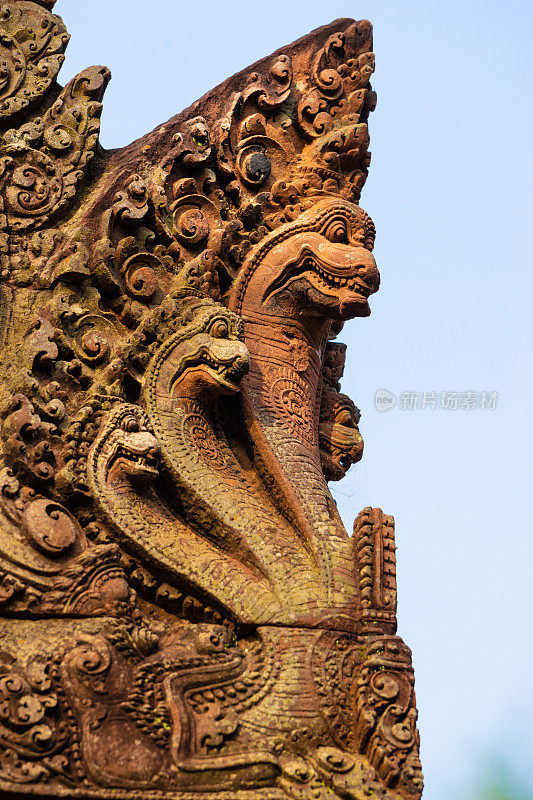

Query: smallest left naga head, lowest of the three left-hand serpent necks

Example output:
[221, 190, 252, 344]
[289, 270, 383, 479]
[98, 410, 160, 483]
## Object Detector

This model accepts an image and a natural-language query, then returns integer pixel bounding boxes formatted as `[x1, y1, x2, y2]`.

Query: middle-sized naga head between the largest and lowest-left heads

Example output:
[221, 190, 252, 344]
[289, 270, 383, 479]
[148, 299, 249, 399]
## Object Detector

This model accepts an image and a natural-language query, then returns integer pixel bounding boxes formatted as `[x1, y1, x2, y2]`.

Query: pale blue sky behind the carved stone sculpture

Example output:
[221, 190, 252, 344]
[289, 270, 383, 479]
[56, 0, 533, 800]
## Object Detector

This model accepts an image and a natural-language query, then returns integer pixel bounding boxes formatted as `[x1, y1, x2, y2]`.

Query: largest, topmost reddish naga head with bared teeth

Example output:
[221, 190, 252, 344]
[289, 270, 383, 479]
[232, 197, 379, 332]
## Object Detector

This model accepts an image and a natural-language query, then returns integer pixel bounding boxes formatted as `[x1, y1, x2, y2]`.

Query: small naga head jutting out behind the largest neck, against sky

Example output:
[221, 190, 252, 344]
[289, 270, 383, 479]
[318, 390, 364, 481]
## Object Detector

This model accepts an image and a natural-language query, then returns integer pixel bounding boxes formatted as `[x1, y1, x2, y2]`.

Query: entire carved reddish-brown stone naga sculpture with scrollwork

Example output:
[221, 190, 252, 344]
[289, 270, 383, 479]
[0, 0, 422, 800]
